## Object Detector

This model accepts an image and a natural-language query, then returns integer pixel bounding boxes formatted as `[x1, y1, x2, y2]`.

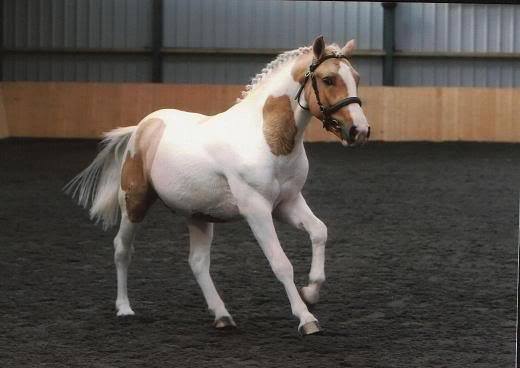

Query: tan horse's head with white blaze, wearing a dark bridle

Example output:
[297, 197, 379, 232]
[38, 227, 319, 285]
[293, 36, 370, 145]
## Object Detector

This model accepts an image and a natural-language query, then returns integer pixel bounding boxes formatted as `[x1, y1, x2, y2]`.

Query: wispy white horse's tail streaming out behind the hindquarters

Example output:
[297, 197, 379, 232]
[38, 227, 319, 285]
[64, 126, 137, 230]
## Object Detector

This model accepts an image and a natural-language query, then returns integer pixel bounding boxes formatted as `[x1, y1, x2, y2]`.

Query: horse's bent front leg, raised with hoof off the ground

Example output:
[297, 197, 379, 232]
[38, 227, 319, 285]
[274, 193, 327, 304]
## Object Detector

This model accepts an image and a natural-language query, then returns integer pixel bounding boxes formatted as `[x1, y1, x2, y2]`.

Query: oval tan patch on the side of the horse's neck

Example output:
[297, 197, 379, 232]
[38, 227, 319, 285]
[262, 95, 297, 156]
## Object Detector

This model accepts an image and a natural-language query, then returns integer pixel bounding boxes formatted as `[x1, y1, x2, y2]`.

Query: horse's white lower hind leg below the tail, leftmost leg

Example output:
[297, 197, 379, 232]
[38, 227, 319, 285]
[114, 212, 138, 316]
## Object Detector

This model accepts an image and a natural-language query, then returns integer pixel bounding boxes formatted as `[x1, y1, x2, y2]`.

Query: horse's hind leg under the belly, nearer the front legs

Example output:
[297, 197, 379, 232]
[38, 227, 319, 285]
[188, 219, 235, 328]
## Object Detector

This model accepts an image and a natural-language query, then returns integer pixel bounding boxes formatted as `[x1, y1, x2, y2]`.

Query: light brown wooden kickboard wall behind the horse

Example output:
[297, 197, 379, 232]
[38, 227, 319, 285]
[0, 82, 520, 142]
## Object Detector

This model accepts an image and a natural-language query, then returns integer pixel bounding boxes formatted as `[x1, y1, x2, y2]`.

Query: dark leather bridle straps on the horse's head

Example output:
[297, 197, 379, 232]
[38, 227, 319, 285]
[294, 53, 361, 132]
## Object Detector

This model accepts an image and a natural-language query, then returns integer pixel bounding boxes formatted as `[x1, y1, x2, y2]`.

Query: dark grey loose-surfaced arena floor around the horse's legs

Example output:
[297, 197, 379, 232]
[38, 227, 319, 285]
[0, 140, 520, 367]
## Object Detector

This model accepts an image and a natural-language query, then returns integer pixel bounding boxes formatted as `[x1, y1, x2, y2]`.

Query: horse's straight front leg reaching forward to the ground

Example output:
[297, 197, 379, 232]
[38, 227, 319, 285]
[232, 180, 320, 335]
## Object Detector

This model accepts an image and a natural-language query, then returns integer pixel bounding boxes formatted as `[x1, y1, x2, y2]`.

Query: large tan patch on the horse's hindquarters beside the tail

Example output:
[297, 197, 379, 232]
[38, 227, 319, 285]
[121, 118, 165, 223]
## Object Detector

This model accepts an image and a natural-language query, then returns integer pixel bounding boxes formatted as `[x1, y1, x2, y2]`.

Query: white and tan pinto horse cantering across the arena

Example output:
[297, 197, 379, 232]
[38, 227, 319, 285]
[65, 36, 370, 335]
